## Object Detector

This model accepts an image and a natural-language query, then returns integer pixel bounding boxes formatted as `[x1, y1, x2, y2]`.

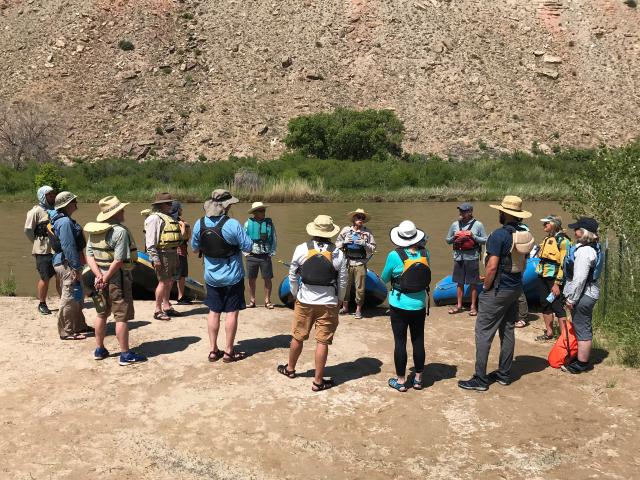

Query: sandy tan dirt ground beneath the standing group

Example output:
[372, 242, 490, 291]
[0, 298, 640, 480]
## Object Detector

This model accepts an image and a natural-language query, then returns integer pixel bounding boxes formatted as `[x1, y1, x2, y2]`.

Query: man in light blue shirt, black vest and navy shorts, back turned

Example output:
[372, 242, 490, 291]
[191, 189, 253, 363]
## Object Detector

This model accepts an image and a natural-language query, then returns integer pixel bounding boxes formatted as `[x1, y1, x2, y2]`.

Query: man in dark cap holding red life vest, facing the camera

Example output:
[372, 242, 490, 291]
[446, 202, 487, 317]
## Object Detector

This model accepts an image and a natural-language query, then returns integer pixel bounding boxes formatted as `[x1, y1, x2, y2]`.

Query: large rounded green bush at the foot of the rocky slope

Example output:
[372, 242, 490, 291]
[284, 108, 404, 160]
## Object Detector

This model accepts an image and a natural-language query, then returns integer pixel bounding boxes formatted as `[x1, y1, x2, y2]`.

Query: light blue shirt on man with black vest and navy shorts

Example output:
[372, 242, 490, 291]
[191, 216, 253, 287]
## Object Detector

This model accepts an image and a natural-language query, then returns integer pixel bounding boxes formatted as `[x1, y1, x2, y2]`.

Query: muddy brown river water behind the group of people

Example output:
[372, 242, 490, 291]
[0, 202, 568, 300]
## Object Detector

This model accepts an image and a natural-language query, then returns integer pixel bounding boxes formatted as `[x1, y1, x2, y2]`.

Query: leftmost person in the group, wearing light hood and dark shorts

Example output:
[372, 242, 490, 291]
[24, 185, 61, 315]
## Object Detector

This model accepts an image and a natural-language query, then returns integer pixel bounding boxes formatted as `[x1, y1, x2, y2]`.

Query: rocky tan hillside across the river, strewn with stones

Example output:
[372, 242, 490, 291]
[0, 0, 640, 159]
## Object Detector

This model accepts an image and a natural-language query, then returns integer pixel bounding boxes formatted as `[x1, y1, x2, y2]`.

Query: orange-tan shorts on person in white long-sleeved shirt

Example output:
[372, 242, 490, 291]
[291, 300, 338, 345]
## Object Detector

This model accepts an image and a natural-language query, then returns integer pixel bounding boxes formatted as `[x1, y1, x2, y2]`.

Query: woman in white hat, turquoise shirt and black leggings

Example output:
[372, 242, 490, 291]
[382, 220, 431, 392]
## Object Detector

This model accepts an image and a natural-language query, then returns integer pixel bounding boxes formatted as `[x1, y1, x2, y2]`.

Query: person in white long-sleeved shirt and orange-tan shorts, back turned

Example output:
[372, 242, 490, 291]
[278, 215, 347, 392]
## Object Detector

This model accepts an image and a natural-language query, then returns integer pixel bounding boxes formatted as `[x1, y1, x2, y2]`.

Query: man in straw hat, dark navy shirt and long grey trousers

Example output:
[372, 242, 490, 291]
[458, 195, 534, 391]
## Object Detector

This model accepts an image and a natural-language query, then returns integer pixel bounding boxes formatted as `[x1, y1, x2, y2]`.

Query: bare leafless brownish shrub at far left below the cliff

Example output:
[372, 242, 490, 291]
[0, 102, 54, 170]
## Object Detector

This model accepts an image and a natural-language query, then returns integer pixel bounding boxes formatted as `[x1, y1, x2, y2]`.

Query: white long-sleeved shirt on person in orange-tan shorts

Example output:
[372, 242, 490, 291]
[289, 240, 347, 305]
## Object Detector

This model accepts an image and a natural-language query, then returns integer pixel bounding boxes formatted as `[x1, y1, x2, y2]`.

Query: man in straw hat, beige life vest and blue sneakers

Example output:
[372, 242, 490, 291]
[84, 196, 146, 366]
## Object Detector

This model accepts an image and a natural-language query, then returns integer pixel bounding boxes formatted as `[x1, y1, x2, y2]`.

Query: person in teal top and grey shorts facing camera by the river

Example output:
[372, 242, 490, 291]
[244, 202, 277, 309]
